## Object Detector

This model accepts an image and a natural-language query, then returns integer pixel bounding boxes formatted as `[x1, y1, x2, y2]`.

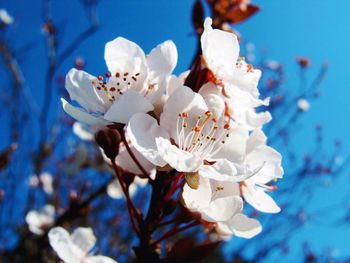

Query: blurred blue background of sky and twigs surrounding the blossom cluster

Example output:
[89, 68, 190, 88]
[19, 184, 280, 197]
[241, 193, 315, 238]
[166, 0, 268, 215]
[0, 0, 350, 262]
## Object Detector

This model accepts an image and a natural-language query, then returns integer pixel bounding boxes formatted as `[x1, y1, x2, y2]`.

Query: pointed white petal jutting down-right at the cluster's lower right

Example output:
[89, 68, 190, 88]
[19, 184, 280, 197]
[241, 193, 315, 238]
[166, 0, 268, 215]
[241, 184, 281, 213]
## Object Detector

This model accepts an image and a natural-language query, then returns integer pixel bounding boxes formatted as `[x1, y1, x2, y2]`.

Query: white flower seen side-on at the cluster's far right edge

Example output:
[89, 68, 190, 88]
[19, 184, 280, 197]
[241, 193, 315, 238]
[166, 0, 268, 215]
[241, 130, 283, 213]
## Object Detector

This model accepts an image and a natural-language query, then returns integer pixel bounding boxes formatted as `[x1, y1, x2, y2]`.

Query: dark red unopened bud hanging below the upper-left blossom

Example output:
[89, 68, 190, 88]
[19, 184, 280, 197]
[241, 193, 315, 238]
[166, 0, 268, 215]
[95, 128, 121, 160]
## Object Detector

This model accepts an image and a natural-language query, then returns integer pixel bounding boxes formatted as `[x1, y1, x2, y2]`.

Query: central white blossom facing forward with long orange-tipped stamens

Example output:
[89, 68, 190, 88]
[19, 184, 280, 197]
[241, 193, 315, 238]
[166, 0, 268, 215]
[127, 87, 248, 184]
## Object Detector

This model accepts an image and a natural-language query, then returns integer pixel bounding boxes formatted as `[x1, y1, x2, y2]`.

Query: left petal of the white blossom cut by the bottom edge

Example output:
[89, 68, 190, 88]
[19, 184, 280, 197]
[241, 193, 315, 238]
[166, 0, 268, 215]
[48, 227, 86, 263]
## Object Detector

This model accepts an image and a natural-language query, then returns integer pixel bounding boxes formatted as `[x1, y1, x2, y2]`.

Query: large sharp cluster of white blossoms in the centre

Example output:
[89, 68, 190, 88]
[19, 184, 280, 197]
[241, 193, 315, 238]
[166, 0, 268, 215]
[58, 14, 283, 260]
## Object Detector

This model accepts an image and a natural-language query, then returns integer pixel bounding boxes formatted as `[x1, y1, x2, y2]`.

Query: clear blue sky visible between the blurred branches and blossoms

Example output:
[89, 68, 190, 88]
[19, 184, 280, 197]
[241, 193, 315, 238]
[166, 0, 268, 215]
[0, 0, 350, 262]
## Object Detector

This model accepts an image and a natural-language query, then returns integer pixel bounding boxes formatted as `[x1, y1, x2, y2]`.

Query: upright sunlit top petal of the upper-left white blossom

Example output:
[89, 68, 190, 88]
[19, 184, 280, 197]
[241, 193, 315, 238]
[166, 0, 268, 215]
[104, 37, 145, 75]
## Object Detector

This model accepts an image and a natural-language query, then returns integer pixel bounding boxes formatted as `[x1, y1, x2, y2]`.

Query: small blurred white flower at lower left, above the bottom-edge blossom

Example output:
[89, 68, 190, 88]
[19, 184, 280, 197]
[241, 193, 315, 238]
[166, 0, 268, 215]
[25, 205, 55, 235]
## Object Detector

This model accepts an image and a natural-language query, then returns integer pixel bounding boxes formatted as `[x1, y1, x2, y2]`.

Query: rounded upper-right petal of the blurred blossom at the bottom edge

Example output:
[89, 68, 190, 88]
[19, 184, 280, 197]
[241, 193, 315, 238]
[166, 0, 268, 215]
[71, 227, 96, 254]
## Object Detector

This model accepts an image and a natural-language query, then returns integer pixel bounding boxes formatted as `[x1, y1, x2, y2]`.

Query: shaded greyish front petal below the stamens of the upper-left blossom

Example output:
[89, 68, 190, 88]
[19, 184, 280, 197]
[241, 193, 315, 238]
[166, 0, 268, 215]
[104, 90, 153, 123]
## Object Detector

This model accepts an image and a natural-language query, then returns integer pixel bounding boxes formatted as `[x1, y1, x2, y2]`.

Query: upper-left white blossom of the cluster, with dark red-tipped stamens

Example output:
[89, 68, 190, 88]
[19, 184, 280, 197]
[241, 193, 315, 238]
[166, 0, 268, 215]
[61, 37, 177, 125]
